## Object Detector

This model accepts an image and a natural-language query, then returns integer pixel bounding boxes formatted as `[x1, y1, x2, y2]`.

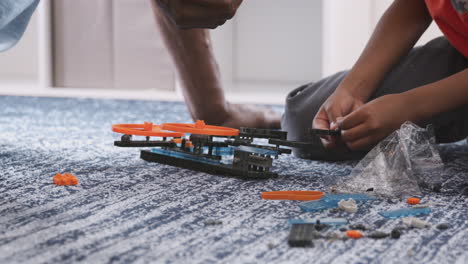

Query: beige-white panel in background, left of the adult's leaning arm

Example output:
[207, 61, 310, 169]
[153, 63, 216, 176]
[53, 0, 174, 90]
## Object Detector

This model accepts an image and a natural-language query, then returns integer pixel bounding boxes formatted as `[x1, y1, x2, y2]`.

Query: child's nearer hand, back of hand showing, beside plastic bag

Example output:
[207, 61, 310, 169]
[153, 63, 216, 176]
[339, 94, 412, 150]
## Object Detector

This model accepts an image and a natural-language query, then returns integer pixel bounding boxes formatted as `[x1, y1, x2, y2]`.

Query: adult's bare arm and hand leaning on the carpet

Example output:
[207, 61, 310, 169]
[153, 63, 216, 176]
[152, 0, 280, 128]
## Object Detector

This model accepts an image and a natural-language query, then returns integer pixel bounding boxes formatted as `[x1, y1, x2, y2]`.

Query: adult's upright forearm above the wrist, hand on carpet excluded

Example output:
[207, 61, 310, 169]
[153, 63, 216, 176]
[153, 2, 226, 123]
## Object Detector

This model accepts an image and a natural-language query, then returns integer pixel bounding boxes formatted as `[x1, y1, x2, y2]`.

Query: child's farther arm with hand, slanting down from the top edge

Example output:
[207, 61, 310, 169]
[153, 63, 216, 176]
[313, 0, 432, 148]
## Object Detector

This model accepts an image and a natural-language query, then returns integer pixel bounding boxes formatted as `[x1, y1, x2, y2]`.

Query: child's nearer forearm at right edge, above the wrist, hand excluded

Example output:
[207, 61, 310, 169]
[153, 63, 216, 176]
[401, 69, 468, 122]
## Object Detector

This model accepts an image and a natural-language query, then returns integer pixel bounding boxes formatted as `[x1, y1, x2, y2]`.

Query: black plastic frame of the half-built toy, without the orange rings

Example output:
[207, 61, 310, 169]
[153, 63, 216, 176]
[114, 128, 362, 179]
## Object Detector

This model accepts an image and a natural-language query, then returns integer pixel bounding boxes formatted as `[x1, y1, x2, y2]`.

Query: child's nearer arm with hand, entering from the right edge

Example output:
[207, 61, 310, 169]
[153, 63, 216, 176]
[341, 70, 468, 150]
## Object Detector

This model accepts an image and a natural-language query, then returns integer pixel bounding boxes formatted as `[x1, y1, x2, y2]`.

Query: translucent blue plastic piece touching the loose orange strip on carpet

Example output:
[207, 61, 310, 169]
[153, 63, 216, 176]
[299, 193, 376, 212]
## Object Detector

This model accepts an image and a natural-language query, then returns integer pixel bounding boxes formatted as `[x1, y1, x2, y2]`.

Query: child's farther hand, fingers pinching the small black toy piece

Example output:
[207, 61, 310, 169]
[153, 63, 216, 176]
[312, 89, 364, 148]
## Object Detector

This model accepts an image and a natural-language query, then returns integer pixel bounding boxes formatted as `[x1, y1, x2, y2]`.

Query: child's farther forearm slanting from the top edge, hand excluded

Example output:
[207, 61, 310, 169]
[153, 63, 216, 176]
[340, 0, 432, 101]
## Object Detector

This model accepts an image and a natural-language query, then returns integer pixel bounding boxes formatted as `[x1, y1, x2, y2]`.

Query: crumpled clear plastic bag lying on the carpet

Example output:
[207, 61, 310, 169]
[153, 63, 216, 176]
[335, 122, 443, 198]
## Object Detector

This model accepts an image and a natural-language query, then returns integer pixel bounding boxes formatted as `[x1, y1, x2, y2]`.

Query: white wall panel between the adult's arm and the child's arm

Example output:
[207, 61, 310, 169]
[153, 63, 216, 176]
[212, 0, 322, 93]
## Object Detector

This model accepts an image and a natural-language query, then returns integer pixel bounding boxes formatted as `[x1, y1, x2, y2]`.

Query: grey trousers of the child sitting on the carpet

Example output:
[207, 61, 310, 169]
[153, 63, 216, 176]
[282, 37, 468, 160]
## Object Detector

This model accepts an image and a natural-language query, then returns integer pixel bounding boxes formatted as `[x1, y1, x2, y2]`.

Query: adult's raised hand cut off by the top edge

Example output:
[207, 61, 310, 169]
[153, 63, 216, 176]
[154, 0, 242, 29]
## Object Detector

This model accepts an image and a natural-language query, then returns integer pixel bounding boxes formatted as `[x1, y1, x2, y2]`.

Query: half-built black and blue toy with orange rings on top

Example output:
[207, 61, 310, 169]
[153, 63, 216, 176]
[112, 121, 291, 179]
